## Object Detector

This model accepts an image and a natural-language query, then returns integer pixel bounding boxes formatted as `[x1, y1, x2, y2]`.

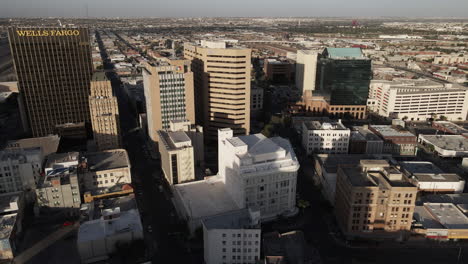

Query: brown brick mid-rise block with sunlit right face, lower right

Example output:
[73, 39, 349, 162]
[335, 160, 417, 238]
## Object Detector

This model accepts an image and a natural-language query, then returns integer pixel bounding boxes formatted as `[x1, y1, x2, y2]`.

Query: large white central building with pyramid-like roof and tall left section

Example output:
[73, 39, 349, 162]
[218, 128, 299, 219]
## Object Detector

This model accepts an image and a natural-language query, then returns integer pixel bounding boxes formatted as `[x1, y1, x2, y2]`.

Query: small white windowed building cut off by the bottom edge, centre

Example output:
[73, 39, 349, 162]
[202, 208, 261, 264]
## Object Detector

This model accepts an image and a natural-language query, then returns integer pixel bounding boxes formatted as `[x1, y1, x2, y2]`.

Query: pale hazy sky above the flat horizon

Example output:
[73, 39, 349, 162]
[0, 0, 468, 18]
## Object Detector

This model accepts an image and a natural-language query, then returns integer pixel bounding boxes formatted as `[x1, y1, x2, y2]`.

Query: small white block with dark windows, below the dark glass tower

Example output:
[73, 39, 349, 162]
[302, 120, 351, 155]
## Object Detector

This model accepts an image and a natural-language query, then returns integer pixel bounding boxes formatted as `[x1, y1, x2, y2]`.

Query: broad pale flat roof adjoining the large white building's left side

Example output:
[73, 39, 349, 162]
[174, 176, 240, 219]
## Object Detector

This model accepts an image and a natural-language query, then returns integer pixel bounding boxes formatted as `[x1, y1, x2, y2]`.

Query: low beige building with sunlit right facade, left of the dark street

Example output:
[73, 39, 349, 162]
[78, 149, 132, 193]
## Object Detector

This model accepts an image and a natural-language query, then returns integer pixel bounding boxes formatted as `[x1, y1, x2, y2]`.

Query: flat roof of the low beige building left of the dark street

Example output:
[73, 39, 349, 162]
[84, 149, 130, 171]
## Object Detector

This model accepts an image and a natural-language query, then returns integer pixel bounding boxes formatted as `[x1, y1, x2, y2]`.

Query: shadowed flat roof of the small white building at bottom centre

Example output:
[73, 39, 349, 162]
[203, 208, 260, 229]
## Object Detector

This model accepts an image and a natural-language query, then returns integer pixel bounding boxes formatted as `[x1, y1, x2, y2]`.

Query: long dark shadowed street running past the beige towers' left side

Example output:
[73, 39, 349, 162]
[96, 30, 203, 264]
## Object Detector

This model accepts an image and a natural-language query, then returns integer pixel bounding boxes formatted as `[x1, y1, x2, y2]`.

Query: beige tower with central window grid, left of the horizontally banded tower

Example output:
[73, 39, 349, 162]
[143, 61, 195, 142]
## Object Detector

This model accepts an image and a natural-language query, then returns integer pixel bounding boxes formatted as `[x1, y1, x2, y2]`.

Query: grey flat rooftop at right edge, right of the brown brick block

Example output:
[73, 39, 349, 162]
[424, 203, 468, 229]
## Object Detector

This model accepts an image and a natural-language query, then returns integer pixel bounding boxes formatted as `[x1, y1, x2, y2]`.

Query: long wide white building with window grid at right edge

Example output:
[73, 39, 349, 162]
[369, 79, 468, 121]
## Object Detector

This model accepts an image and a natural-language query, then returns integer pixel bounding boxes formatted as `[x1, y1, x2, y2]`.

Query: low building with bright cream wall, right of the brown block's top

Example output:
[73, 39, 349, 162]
[400, 161, 465, 193]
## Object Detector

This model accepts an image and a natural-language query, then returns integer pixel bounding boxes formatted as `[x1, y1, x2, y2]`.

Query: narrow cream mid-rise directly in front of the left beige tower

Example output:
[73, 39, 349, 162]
[158, 121, 203, 185]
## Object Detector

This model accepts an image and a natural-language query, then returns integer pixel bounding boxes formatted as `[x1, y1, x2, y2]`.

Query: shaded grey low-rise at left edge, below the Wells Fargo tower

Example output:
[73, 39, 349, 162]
[0, 147, 43, 193]
